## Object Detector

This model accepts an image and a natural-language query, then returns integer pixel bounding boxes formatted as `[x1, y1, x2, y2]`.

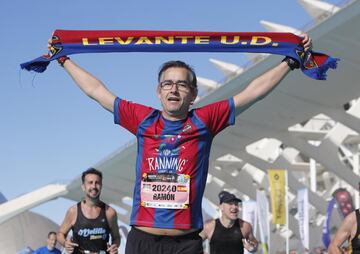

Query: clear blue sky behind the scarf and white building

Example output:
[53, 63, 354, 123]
[0, 0, 336, 239]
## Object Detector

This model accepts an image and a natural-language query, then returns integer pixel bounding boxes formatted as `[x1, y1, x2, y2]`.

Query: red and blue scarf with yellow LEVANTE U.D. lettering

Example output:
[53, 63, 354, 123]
[20, 30, 339, 80]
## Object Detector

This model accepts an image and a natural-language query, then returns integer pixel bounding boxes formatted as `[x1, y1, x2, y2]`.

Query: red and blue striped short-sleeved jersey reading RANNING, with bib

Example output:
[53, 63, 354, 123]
[114, 98, 235, 229]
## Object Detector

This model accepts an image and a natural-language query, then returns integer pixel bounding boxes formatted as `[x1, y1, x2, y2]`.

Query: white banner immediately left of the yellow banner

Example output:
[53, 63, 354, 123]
[256, 190, 270, 254]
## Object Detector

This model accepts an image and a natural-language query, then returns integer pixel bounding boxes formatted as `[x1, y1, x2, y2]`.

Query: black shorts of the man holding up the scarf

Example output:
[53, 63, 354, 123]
[125, 227, 204, 254]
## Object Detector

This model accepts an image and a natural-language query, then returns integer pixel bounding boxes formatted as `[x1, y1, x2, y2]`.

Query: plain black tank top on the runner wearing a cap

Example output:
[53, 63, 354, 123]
[210, 219, 244, 254]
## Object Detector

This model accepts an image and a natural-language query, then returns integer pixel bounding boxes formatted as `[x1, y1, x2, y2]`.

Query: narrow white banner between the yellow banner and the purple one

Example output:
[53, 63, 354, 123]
[297, 188, 309, 250]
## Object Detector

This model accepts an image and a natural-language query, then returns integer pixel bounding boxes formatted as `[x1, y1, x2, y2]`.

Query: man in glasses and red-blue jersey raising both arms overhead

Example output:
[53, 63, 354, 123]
[48, 34, 311, 254]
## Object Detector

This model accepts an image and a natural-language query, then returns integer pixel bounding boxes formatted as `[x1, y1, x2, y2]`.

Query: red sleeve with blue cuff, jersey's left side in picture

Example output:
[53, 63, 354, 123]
[114, 98, 154, 135]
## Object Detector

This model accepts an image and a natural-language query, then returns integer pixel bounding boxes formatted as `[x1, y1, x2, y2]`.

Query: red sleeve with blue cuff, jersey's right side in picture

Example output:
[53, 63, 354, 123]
[195, 98, 235, 136]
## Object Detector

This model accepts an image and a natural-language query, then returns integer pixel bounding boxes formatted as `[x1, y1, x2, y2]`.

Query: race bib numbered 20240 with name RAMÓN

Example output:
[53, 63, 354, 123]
[141, 173, 190, 209]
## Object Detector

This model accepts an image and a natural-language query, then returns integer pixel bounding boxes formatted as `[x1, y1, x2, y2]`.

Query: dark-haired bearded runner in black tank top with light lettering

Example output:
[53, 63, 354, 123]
[57, 168, 121, 254]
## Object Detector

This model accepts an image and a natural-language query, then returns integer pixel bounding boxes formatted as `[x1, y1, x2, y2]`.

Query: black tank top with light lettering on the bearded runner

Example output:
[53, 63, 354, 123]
[72, 202, 110, 254]
